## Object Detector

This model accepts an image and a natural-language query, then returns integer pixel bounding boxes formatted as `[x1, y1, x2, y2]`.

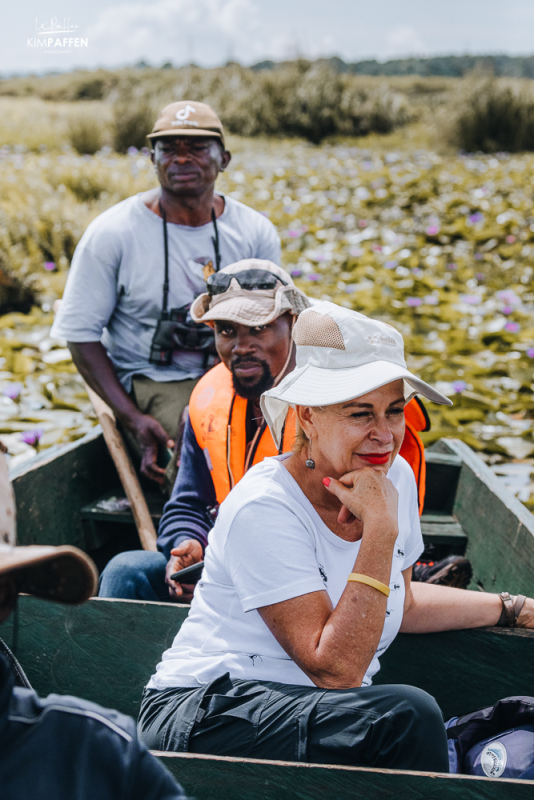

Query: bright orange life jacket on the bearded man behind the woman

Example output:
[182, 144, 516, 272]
[189, 364, 428, 513]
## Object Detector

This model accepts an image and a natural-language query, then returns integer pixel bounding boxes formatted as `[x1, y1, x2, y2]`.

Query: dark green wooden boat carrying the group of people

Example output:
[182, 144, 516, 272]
[2, 428, 534, 800]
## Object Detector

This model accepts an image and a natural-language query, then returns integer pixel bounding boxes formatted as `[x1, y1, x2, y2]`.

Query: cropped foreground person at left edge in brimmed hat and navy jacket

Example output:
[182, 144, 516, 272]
[0, 446, 186, 800]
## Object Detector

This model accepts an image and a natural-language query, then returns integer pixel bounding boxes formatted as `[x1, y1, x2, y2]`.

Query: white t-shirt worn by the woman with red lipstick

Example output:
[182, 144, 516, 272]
[148, 454, 423, 690]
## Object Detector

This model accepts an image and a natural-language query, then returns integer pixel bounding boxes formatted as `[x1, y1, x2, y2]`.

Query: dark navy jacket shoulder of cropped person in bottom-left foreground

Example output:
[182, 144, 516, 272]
[0, 657, 185, 800]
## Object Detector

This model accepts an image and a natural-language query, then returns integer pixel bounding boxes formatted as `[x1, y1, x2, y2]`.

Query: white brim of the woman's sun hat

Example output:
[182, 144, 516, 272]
[260, 361, 452, 447]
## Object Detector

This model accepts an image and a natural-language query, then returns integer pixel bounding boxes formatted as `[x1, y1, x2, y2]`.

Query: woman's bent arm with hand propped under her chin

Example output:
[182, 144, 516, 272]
[258, 469, 398, 689]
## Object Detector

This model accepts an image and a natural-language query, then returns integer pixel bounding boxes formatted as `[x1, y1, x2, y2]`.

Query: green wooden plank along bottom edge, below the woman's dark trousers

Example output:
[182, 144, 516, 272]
[157, 753, 533, 800]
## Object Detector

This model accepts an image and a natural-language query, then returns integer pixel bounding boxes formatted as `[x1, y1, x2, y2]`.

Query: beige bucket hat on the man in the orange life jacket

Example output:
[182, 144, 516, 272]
[191, 258, 310, 327]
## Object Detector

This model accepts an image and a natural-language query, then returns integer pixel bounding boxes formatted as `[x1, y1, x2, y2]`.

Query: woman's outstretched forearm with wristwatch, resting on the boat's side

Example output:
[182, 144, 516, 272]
[400, 567, 534, 633]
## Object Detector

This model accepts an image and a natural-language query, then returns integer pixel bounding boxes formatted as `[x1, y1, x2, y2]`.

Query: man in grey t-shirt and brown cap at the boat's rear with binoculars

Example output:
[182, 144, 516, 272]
[52, 101, 280, 483]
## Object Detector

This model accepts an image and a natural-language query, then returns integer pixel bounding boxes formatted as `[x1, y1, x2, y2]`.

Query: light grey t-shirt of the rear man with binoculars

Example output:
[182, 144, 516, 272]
[51, 194, 280, 392]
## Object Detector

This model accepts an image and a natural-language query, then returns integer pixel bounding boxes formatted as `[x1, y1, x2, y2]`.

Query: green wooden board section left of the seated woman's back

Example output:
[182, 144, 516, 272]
[2, 596, 189, 717]
